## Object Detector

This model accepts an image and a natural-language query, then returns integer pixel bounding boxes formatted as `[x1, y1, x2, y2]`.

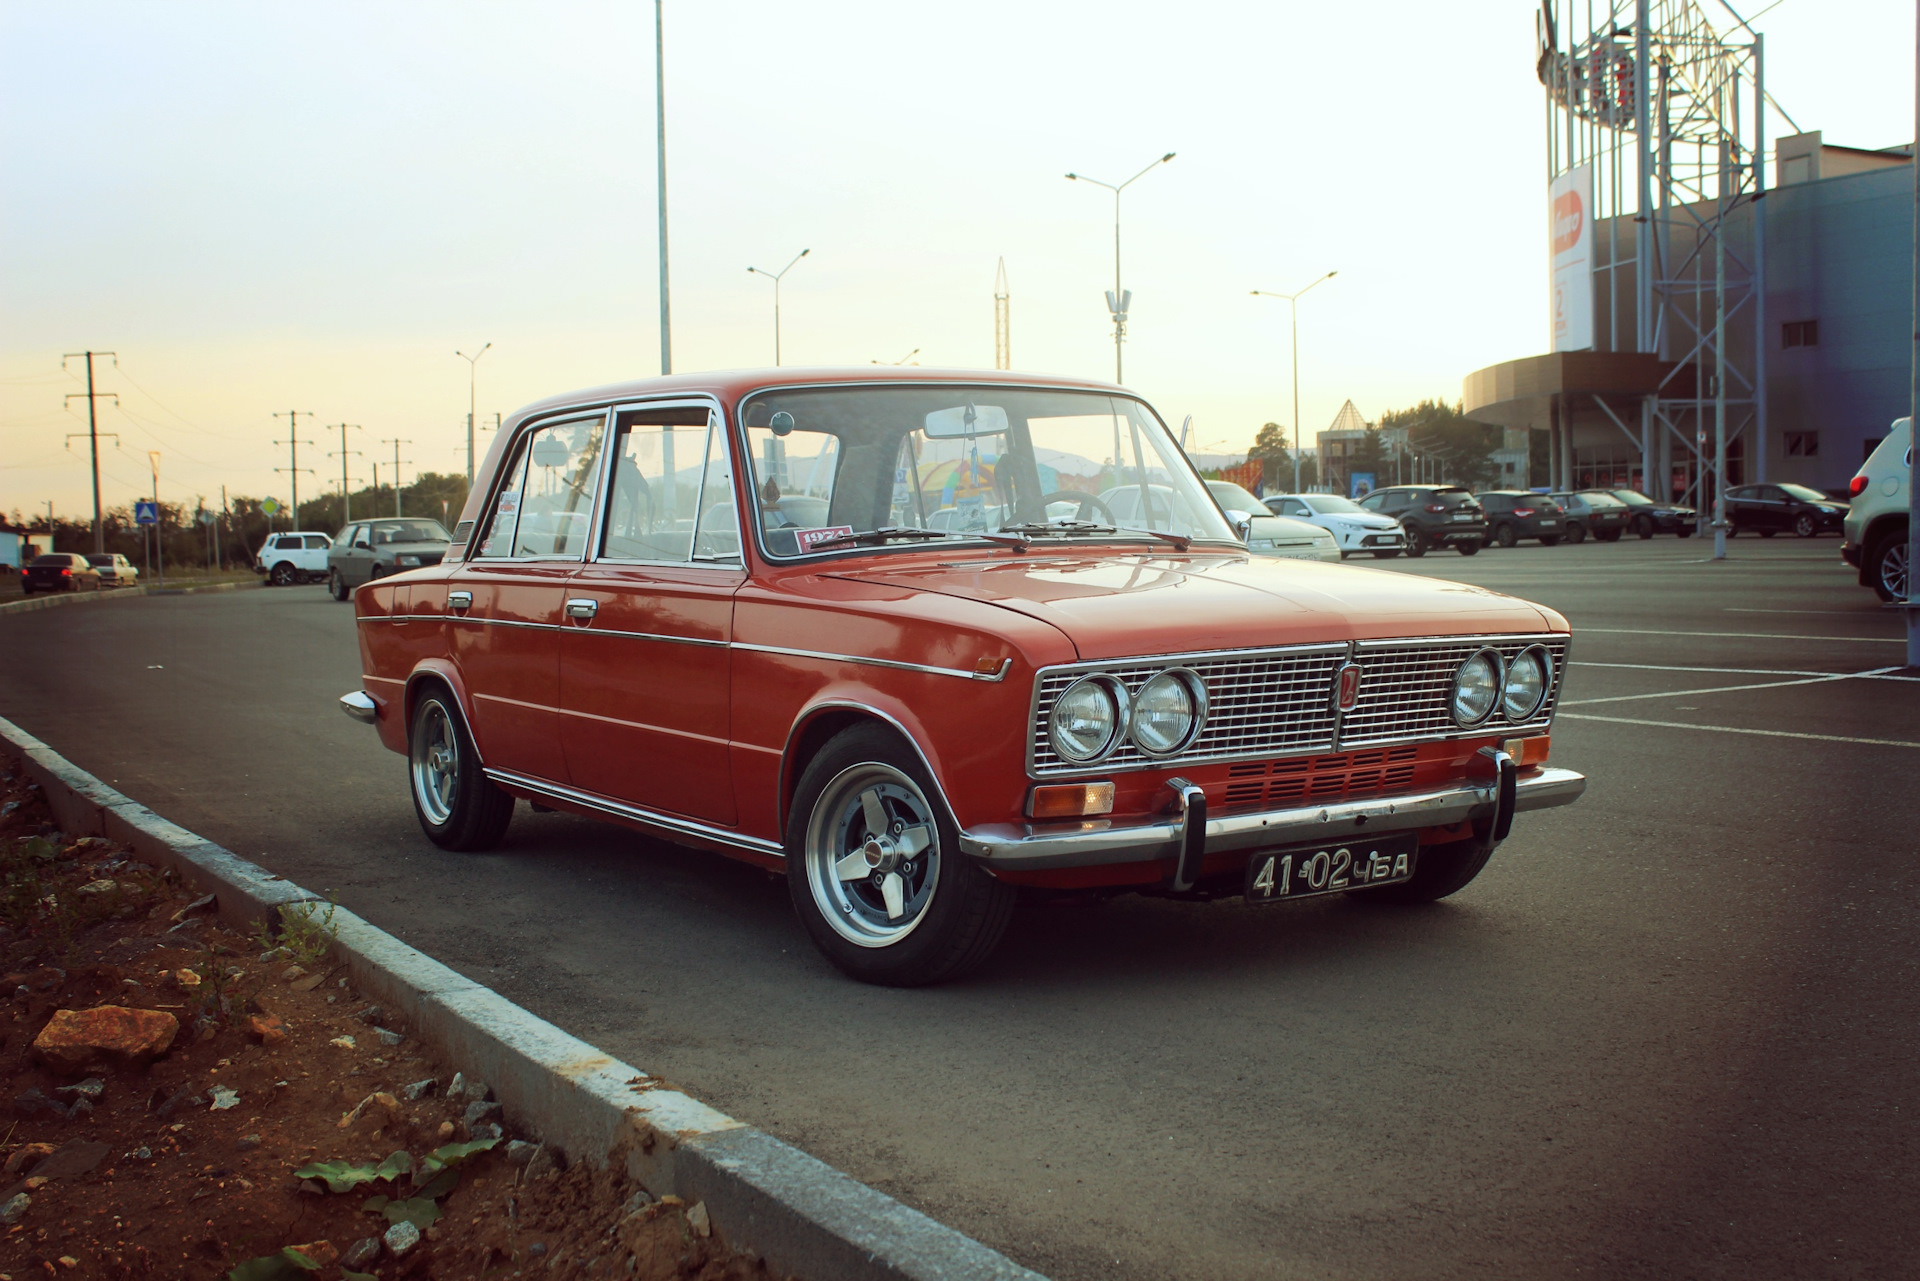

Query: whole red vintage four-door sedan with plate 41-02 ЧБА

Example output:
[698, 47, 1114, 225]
[342, 369, 1586, 985]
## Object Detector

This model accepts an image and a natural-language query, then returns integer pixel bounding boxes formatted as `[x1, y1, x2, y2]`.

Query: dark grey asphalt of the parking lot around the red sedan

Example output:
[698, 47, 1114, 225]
[0, 538, 1920, 1279]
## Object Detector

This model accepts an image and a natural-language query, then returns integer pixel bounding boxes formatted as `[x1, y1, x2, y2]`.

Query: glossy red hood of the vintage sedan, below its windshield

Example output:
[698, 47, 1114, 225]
[826, 551, 1567, 659]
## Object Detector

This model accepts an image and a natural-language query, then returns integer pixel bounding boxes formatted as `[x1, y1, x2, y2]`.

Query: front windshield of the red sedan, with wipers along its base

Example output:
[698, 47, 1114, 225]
[741, 384, 1228, 557]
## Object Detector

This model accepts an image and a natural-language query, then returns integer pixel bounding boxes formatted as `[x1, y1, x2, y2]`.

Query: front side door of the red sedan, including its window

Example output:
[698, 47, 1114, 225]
[561, 401, 747, 824]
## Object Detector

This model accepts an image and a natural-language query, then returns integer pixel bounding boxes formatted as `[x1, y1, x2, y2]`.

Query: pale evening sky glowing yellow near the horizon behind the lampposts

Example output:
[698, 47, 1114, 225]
[0, 0, 1914, 517]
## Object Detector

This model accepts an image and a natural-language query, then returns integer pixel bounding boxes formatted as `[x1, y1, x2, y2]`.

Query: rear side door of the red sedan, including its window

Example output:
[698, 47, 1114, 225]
[449, 409, 607, 784]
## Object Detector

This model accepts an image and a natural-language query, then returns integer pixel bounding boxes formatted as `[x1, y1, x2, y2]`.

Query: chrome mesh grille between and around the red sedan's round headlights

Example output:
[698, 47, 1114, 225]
[1029, 636, 1567, 776]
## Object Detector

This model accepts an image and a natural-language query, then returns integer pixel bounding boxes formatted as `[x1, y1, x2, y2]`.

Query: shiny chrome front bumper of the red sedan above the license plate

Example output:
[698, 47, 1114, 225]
[960, 766, 1586, 872]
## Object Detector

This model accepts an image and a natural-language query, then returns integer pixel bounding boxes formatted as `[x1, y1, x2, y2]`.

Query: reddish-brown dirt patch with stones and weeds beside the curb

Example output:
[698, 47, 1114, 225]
[0, 755, 791, 1281]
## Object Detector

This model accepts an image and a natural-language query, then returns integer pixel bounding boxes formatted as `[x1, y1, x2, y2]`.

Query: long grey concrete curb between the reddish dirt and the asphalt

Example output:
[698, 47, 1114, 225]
[0, 710, 1044, 1281]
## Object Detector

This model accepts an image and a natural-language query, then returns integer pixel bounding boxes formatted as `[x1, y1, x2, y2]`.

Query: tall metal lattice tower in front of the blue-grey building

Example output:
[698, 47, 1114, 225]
[1538, 0, 1791, 509]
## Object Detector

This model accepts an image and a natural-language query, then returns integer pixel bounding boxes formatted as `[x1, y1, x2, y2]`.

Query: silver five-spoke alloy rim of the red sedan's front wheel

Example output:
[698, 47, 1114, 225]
[804, 761, 941, 947]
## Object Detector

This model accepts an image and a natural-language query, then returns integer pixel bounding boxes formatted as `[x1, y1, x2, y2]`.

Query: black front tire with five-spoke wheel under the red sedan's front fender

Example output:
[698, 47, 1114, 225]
[787, 724, 1014, 987]
